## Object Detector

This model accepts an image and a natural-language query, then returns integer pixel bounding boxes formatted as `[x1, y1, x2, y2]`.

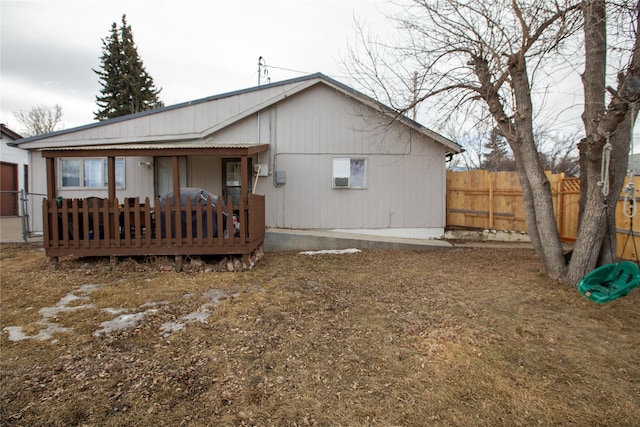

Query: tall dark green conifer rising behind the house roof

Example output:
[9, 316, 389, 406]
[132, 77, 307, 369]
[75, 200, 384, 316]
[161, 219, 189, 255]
[93, 15, 164, 120]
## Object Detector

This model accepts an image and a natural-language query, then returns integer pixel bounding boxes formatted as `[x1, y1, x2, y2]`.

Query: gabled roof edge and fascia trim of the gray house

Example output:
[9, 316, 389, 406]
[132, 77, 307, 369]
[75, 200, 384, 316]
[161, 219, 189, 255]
[19, 73, 462, 153]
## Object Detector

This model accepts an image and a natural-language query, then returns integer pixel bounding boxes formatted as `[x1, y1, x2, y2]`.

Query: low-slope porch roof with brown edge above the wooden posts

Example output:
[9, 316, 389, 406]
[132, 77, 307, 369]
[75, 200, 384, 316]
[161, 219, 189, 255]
[38, 142, 269, 158]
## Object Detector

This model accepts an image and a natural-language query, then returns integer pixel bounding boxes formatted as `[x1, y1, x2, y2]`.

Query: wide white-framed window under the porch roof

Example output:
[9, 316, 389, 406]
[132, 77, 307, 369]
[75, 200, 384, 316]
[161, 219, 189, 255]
[60, 157, 124, 188]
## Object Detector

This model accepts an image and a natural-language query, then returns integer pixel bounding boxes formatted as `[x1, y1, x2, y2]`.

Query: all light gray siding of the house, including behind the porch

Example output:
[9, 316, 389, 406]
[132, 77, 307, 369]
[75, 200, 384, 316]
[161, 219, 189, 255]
[27, 76, 446, 237]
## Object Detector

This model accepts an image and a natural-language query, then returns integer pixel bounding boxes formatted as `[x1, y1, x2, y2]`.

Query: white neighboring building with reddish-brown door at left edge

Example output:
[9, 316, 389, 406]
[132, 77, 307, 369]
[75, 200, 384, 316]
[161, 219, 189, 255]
[0, 124, 29, 242]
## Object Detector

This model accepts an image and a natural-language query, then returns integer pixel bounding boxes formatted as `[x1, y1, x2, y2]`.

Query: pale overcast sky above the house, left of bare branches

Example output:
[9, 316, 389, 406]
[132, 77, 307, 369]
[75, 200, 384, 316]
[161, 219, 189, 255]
[0, 0, 390, 132]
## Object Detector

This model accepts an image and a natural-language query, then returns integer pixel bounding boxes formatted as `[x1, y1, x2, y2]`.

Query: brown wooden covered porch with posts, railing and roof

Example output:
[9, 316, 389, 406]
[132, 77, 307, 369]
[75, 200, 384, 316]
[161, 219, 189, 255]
[41, 143, 269, 269]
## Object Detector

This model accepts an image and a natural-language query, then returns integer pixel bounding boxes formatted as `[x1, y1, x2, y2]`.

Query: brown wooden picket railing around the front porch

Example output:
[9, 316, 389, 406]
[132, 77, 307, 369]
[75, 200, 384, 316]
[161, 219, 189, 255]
[43, 194, 265, 257]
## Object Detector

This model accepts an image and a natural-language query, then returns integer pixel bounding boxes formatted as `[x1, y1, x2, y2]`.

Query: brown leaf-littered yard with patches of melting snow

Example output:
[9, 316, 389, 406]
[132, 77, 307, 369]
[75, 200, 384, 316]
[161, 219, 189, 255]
[0, 242, 640, 426]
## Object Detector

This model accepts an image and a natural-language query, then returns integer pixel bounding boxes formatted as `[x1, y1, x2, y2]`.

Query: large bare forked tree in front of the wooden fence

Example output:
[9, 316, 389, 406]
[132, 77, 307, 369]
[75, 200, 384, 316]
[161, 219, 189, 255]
[347, 0, 640, 283]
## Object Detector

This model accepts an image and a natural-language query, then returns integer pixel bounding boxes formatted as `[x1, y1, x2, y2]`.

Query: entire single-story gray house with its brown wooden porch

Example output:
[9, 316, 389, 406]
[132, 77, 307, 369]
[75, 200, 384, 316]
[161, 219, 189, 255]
[20, 74, 460, 257]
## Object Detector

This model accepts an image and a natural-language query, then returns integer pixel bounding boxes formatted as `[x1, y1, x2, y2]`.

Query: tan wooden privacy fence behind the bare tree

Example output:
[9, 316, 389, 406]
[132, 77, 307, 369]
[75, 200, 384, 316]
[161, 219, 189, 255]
[447, 170, 640, 260]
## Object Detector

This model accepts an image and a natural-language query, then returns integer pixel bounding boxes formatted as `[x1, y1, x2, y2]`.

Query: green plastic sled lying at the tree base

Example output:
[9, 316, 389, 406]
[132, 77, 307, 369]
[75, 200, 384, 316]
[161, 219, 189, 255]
[578, 261, 640, 304]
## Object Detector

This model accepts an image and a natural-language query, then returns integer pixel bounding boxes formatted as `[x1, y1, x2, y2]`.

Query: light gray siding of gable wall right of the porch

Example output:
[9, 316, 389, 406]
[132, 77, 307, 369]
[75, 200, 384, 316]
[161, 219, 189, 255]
[254, 86, 446, 229]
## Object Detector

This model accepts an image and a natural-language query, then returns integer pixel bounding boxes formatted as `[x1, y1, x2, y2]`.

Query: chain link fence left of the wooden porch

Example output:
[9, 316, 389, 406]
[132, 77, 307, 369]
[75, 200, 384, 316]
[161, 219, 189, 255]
[0, 190, 46, 243]
